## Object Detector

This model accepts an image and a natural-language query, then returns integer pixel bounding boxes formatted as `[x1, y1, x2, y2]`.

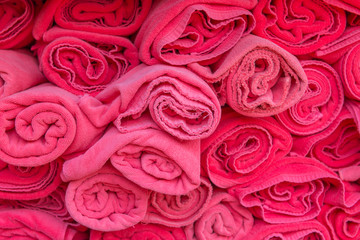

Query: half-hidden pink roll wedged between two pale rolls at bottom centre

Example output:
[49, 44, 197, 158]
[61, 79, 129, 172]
[142, 177, 212, 227]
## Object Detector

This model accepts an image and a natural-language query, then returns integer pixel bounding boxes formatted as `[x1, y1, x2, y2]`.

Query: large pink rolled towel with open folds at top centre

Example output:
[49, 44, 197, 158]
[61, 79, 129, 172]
[135, 0, 257, 65]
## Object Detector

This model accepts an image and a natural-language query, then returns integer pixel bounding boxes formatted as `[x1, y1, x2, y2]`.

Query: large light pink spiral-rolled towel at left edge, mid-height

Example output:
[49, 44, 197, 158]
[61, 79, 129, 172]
[0, 83, 104, 167]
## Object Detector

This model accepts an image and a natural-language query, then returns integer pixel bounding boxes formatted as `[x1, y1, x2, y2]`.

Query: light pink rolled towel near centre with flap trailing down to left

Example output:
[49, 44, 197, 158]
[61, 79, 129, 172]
[62, 122, 200, 195]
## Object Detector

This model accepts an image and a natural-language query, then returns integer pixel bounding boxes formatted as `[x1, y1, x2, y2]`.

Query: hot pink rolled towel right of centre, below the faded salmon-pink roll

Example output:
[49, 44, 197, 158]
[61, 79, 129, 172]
[201, 109, 292, 188]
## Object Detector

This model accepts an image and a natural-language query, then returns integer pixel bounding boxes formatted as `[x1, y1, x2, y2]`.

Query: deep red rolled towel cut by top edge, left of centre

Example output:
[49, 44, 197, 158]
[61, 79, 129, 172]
[33, 0, 152, 40]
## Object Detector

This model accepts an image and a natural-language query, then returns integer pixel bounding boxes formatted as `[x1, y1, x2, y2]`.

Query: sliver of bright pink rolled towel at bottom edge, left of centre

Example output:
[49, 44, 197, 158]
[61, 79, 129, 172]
[90, 223, 186, 240]
